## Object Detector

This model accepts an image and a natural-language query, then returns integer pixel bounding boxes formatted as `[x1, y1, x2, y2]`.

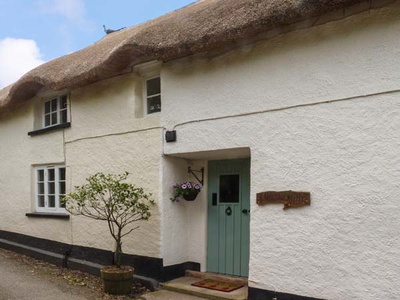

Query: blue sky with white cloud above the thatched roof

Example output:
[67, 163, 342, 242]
[0, 0, 195, 89]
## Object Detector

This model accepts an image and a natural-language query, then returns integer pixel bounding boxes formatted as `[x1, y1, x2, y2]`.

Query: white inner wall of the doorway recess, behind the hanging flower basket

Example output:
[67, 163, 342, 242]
[160, 157, 207, 271]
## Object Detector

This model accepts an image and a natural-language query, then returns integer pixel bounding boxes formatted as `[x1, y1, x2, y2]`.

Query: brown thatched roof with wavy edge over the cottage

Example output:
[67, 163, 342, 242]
[0, 0, 382, 113]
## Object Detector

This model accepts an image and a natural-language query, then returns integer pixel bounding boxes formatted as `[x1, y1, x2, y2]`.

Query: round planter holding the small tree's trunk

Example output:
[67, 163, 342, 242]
[100, 266, 133, 295]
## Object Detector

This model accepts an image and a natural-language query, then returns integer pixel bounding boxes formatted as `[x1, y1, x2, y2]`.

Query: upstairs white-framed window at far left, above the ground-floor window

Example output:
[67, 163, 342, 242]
[43, 95, 68, 128]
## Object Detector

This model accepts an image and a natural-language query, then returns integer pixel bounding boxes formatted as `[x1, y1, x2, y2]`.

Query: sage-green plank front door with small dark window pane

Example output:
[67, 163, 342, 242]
[207, 159, 250, 277]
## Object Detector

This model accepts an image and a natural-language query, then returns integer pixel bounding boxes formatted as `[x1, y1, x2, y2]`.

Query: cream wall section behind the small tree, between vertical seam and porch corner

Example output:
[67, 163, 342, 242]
[65, 75, 163, 257]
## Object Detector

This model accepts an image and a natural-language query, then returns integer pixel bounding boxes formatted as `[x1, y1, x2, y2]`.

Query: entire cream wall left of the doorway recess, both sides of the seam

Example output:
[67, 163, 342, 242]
[0, 74, 163, 257]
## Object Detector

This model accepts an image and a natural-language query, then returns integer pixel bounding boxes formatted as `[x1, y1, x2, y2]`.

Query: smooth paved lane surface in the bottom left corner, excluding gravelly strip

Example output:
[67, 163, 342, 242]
[0, 251, 101, 300]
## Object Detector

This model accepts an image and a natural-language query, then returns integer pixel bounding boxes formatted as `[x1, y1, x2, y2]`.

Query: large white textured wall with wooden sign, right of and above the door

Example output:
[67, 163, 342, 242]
[162, 4, 400, 299]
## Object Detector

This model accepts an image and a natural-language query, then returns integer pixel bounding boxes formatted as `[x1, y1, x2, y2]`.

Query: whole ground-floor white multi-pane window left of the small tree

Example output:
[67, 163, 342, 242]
[35, 166, 66, 212]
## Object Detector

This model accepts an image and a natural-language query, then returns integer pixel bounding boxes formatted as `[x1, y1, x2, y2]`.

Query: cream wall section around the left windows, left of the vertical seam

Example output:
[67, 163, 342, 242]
[0, 103, 70, 243]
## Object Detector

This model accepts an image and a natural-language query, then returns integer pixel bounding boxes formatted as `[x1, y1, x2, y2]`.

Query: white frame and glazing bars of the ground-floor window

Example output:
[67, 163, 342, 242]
[34, 165, 67, 214]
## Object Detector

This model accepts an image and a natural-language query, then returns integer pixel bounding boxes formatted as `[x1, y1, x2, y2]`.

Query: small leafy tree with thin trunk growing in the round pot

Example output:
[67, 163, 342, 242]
[63, 172, 154, 268]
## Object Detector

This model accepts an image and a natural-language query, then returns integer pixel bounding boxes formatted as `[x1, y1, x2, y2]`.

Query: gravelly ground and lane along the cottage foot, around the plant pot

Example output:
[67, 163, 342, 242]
[0, 249, 149, 300]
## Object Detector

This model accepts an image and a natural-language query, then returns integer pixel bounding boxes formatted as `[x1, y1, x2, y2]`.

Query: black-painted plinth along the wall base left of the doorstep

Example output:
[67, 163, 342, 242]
[0, 230, 200, 286]
